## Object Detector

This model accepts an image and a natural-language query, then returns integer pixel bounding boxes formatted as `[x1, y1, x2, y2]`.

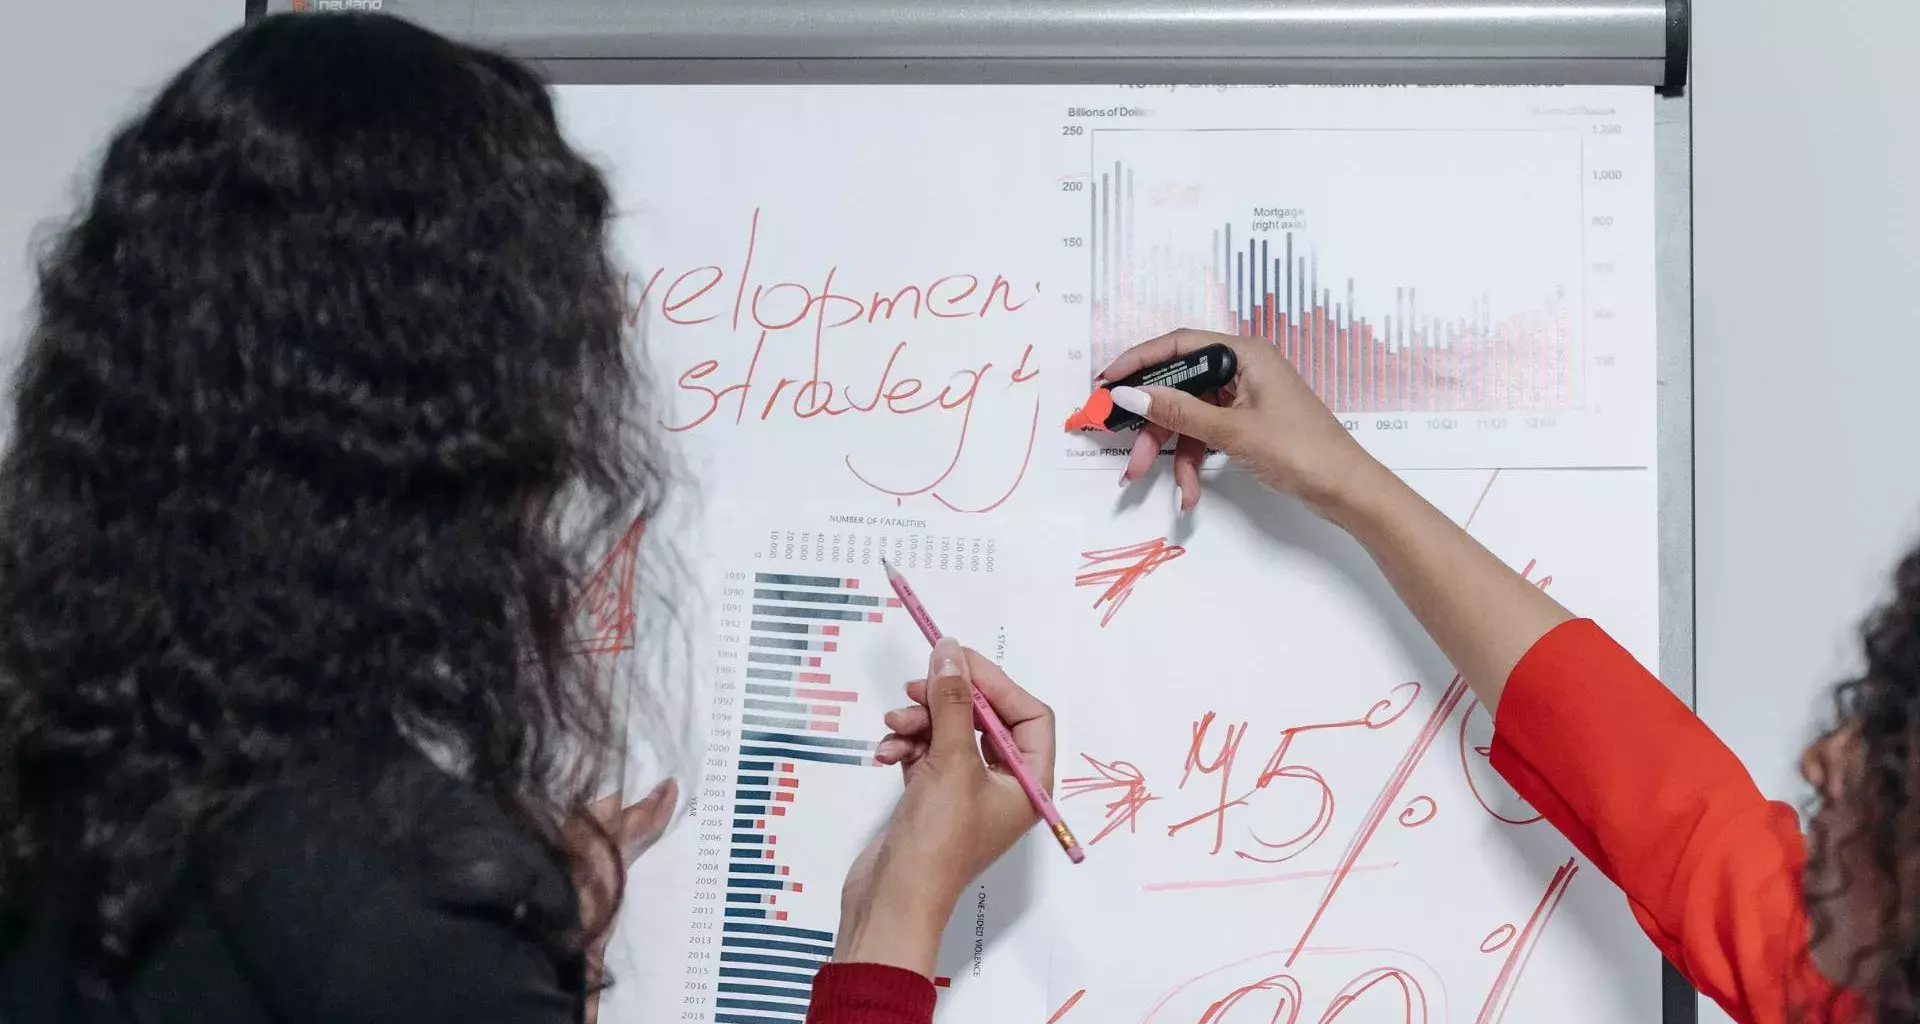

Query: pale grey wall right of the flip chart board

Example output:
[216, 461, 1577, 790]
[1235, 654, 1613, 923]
[1693, 0, 1920, 1020]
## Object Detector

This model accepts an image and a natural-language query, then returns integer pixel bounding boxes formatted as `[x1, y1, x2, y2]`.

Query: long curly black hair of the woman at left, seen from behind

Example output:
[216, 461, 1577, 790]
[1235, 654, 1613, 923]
[0, 15, 662, 966]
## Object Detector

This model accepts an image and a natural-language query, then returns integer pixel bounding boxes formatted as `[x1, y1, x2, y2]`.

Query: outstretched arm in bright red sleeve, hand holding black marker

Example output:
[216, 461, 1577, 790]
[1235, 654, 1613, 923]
[1104, 330, 1845, 1024]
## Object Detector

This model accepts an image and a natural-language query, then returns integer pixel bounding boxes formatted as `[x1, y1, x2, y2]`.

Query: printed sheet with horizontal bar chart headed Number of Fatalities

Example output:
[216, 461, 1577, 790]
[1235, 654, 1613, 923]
[664, 522, 1046, 1024]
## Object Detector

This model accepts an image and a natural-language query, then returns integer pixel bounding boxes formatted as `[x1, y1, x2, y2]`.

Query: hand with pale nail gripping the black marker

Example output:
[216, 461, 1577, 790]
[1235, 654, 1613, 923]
[1100, 330, 1382, 515]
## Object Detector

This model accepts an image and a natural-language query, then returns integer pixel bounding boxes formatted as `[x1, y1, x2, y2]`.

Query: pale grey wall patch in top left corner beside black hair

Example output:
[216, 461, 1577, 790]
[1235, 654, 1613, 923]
[0, 0, 246, 347]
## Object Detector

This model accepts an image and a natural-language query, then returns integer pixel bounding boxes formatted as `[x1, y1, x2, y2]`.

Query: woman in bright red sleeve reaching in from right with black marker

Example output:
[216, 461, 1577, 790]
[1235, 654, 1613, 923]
[1104, 330, 1889, 1024]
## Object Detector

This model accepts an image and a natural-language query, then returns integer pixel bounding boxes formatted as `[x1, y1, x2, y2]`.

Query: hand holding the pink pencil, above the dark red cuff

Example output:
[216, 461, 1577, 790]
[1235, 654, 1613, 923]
[833, 640, 1054, 978]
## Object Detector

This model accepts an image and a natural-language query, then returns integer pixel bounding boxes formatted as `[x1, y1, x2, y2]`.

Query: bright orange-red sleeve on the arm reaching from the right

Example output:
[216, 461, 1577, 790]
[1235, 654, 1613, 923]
[1492, 619, 1858, 1024]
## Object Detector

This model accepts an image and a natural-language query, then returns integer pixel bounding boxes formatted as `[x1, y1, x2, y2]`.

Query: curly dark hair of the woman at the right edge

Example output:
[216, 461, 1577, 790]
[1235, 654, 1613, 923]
[1801, 548, 1920, 1024]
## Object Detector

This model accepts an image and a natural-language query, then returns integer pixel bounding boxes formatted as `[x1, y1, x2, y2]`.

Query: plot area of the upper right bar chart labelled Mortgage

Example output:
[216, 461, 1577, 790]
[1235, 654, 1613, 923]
[1085, 129, 1586, 413]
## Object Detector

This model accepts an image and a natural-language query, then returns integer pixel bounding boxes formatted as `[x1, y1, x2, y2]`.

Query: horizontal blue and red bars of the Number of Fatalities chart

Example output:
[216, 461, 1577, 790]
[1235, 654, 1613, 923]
[712, 571, 947, 1024]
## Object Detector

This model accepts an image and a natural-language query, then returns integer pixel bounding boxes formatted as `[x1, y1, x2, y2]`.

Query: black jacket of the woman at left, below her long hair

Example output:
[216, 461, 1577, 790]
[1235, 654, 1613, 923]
[0, 761, 584, 1024]
